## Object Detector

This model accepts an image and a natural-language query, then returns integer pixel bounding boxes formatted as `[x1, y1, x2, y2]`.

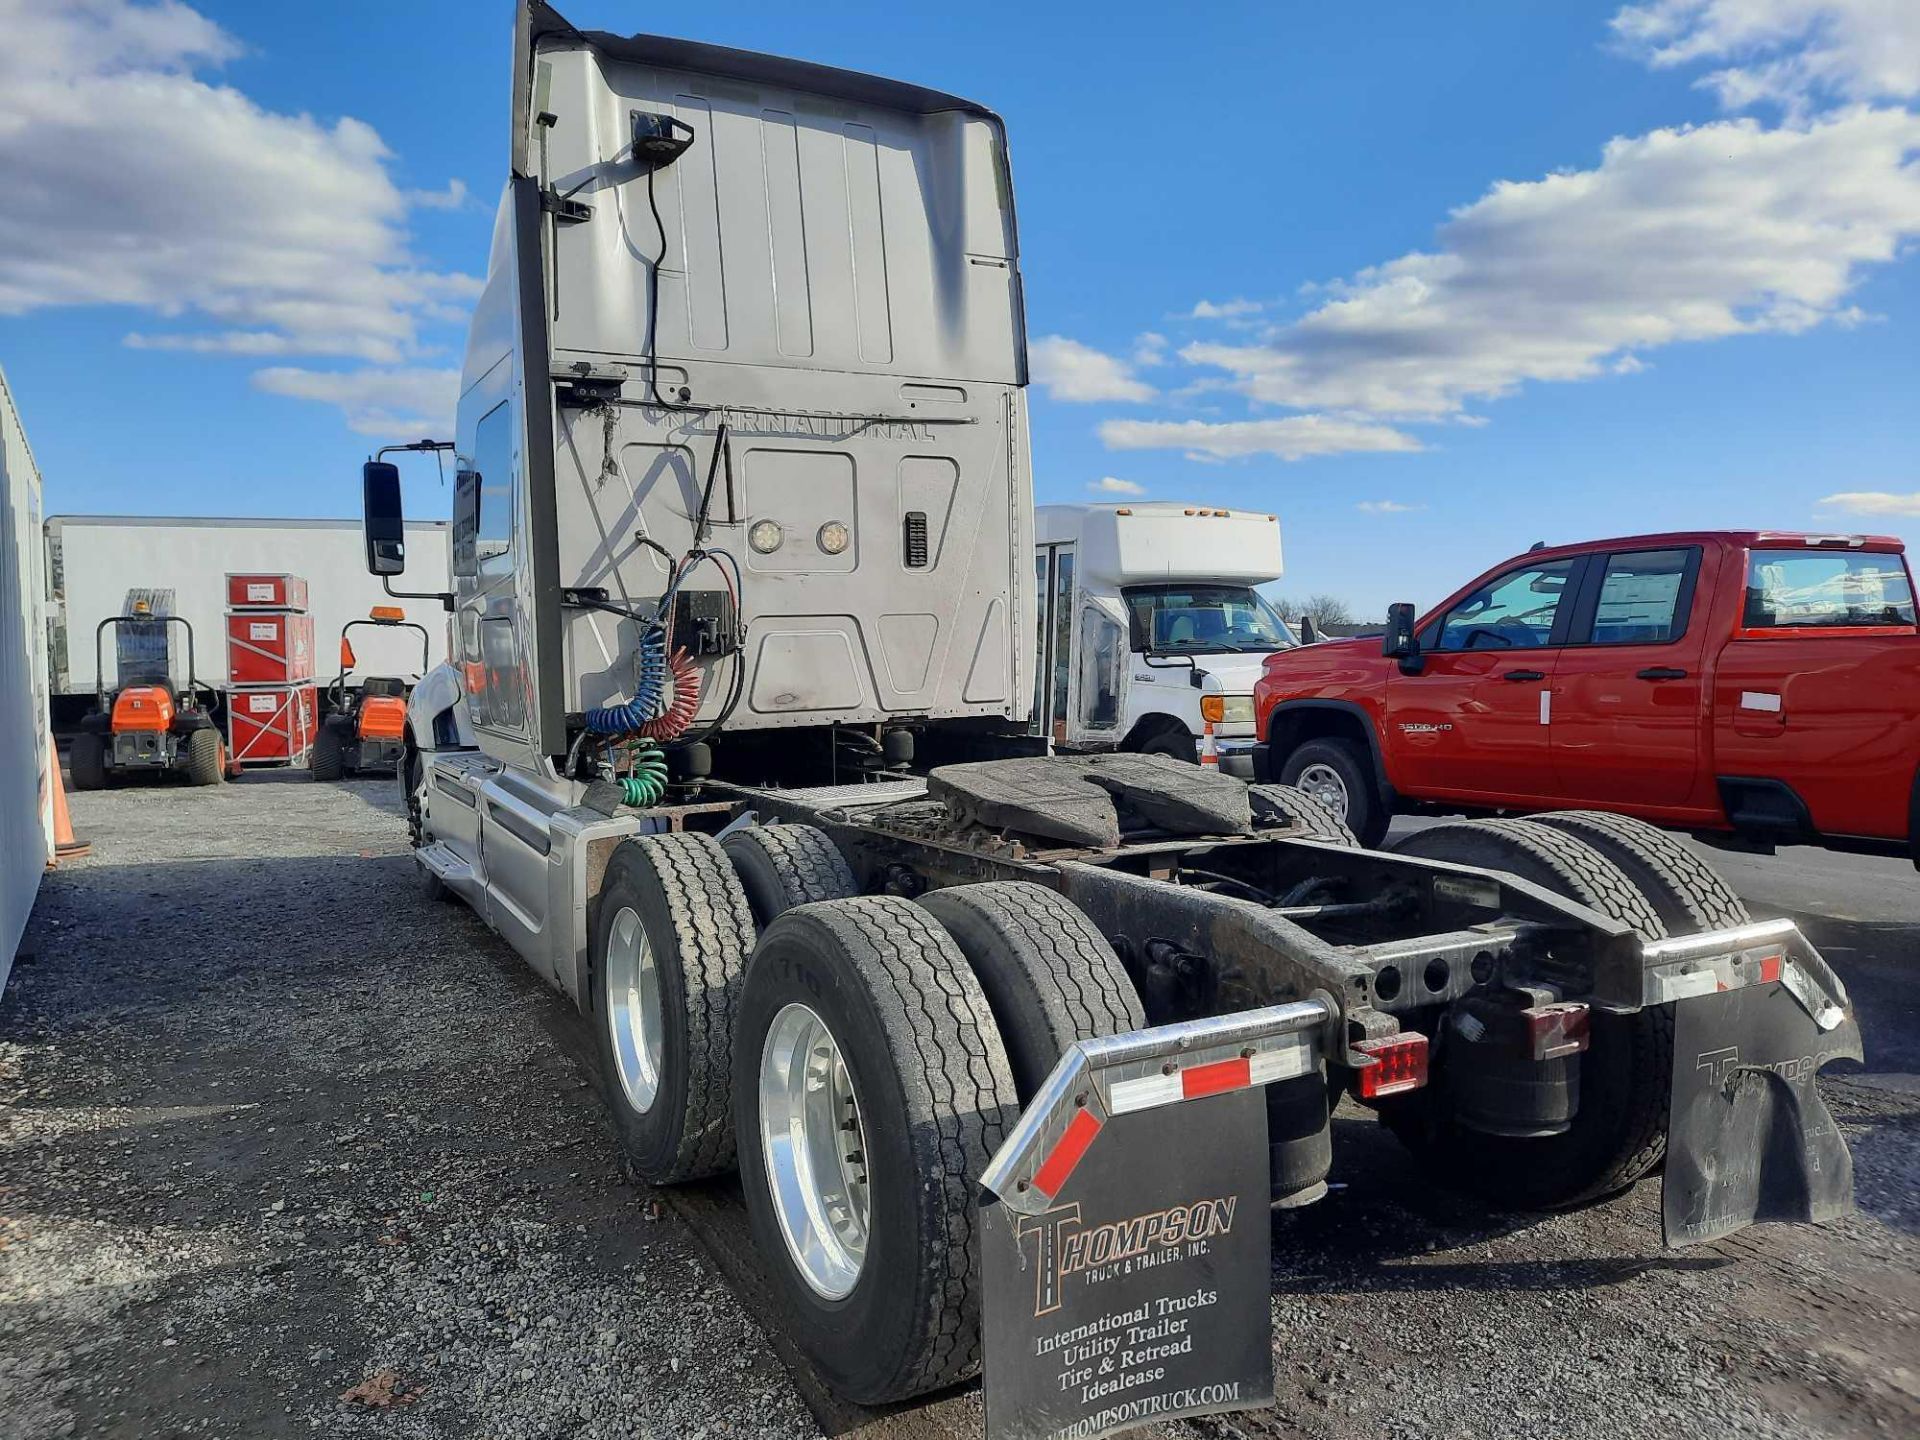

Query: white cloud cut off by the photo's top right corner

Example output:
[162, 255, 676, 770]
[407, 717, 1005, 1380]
[1611, 0, 1920, 115]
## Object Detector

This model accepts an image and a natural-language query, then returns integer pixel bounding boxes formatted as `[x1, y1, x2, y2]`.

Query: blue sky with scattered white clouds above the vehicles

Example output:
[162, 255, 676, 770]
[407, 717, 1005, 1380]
[0, 0, 1920, 614]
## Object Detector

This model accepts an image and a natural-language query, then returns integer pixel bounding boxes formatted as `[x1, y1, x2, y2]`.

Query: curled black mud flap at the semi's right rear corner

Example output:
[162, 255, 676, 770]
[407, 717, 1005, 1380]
[1661, 973, 1860, 1246]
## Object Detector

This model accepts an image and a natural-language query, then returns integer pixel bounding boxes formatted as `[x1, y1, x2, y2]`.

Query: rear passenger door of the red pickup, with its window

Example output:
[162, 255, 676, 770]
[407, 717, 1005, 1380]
[1549, 545, 1715, 808]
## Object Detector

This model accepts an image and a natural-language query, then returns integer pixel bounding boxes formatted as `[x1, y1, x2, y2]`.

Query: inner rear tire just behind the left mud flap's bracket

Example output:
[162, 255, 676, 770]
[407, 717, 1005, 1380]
[920, 879, 1146, 1104]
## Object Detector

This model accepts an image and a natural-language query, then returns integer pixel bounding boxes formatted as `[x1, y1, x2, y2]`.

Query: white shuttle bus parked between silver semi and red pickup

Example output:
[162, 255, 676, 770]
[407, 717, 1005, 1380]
[1035, 503, 1300, 780]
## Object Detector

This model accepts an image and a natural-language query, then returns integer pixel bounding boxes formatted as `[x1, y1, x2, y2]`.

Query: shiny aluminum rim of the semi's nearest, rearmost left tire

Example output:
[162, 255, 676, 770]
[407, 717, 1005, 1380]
[760, 1004, 870, 1300]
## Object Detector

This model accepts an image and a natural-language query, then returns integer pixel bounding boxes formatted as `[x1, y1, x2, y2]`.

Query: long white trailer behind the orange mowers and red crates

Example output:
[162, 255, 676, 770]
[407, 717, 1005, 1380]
[46, 515, 447, 697]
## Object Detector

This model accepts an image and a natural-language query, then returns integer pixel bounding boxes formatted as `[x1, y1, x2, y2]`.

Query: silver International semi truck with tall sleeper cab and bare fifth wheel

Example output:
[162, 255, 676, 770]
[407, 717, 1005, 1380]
[363, 0, 1859, 1436]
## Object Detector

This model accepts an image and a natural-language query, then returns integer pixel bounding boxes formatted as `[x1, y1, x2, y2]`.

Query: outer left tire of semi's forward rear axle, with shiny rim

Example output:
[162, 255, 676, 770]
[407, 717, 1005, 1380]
[591, 831, 753, 1185]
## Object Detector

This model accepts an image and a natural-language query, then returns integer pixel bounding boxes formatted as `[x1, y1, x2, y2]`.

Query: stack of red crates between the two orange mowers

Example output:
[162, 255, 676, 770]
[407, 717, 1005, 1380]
[227, 574, 319, 766]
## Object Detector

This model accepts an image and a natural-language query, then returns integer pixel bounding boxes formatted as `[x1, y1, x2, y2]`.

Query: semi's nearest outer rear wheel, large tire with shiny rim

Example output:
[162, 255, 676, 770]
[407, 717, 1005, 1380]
[733, 895, 1018, 1405]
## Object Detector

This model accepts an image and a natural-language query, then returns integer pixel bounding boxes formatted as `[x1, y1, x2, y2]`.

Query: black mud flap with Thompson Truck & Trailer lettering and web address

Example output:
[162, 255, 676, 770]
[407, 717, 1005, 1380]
[981, 1089, 1273, 1440]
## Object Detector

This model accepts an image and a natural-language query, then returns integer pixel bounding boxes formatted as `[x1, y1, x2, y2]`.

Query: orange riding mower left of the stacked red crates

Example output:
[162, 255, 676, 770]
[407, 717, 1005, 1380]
[67, 607, 227, 789]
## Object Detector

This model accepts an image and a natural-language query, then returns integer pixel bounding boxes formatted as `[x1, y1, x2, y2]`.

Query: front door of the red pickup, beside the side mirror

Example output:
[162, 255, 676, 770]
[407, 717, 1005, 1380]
[1382, 557, 1582, 803]
